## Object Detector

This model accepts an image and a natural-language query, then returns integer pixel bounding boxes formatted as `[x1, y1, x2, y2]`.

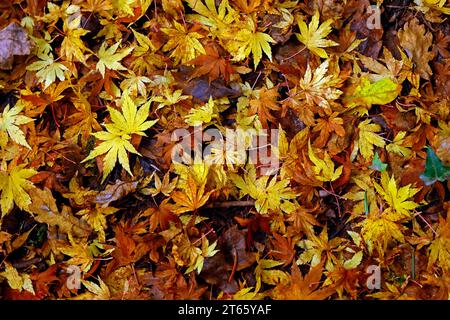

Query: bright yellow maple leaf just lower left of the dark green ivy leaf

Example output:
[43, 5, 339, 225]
[374, 171, 420, 221]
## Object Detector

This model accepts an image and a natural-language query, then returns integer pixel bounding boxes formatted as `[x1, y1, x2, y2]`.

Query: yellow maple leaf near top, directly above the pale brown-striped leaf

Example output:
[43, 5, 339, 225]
[295, 11, 339, 59]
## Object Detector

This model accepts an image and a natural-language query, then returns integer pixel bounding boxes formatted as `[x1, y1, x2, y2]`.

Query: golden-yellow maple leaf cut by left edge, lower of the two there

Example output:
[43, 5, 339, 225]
[0, 164, 37, 217]
